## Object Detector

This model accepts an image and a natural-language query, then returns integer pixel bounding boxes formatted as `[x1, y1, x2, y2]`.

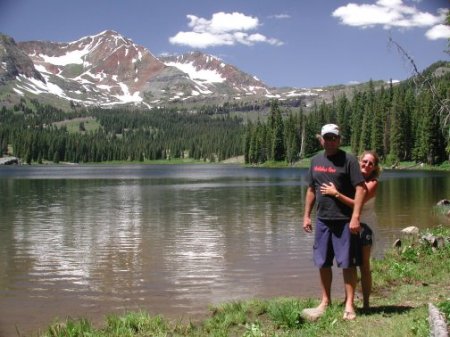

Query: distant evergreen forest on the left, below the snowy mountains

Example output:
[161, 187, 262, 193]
[0, 102, 243, 163]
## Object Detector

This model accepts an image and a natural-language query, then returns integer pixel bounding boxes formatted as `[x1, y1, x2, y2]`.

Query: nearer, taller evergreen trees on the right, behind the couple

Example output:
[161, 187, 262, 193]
[244, 62, 450, 165]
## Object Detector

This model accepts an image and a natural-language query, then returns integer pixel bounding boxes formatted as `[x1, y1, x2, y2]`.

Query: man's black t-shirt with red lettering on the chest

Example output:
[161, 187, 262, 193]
[308, 150, 364, 220]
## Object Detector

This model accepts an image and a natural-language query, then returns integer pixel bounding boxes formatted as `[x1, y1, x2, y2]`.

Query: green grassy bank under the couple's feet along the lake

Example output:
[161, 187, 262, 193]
[32, 225, 450, 337]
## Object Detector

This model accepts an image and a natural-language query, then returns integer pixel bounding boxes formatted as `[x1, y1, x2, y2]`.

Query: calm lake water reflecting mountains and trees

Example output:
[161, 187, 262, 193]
[0, 165, 450, 337]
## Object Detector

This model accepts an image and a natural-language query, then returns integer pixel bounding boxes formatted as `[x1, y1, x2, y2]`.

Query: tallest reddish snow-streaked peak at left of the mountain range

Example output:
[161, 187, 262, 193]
[17, 31, 167, 105]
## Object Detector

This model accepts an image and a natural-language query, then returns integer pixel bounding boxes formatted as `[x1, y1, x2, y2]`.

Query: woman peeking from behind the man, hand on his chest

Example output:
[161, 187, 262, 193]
[320, 151, 381, 309]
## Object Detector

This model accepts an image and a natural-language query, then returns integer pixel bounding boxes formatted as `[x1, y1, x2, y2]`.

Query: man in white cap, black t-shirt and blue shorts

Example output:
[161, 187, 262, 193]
[302, 124, 366, 320]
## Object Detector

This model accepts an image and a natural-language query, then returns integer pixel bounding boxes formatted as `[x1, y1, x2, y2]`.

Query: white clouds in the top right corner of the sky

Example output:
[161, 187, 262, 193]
[332, 0, 448, 39]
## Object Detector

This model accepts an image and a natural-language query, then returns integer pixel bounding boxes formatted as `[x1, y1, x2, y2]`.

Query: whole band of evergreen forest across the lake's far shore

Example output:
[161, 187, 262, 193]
[0, 62, 450, 165]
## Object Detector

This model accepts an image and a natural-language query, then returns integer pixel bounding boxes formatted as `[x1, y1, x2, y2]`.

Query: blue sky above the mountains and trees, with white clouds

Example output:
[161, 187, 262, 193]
[0, 0, 450, 88]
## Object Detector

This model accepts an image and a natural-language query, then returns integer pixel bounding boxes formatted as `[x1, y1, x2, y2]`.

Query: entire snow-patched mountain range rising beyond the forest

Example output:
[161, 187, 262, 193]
[0, 30, 322, 108]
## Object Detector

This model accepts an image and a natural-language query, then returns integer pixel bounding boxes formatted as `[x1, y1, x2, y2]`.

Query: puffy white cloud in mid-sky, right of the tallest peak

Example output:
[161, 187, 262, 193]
[169, 12, 283, 48]
